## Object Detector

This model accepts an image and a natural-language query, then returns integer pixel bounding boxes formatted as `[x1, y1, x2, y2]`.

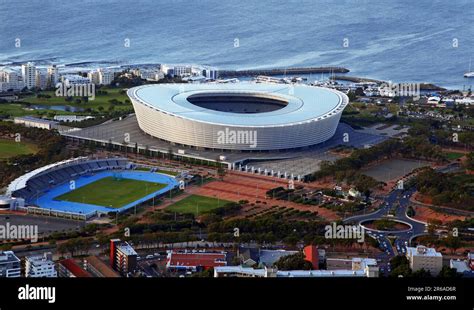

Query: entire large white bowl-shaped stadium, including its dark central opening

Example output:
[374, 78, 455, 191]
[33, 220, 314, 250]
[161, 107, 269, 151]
[127, 82, 349, 151]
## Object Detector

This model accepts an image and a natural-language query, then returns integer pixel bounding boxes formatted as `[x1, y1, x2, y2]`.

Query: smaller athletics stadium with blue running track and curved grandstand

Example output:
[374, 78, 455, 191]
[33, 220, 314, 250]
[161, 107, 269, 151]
[7, 157, 179, 220]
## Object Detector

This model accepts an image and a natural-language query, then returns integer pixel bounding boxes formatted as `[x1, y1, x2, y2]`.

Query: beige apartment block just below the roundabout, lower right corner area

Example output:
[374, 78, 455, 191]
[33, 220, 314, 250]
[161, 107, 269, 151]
[406, 245, 443, 276]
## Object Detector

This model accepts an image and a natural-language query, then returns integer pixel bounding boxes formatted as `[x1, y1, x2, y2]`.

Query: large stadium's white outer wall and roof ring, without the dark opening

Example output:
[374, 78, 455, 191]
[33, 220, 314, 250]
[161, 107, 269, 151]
[128, 83, 349, 150]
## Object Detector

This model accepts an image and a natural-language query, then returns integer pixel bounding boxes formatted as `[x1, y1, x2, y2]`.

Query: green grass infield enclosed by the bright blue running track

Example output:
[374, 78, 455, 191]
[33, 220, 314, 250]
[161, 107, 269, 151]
[54, 177, 166, 208]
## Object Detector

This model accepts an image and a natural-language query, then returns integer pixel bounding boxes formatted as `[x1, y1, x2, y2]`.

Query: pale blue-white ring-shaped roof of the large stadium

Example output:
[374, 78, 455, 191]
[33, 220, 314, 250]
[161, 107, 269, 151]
[129, 82, 347, 127]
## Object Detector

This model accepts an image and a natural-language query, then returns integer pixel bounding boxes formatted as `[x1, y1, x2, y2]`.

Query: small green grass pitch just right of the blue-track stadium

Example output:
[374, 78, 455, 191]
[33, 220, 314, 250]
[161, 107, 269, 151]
[166, 195, 230, 215]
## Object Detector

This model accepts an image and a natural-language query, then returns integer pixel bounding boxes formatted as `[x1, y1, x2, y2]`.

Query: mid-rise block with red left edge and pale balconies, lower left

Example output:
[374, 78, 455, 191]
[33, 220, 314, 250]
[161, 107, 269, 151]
[110, 239, 138, 275]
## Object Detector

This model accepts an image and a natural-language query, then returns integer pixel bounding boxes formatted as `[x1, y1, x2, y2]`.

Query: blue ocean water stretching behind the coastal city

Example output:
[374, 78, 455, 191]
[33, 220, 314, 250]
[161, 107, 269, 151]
[0, 0, 474, 88]
